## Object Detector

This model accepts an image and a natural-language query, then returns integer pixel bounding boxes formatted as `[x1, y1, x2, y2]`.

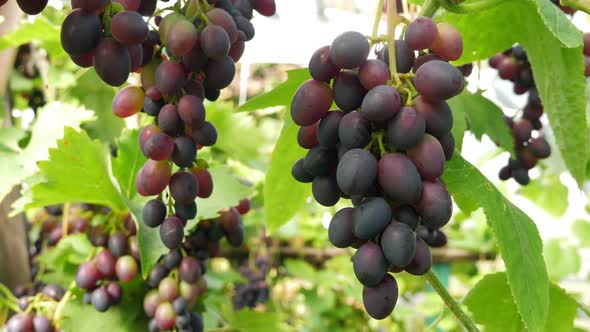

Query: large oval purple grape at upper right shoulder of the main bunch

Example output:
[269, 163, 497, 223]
[414, 60, 465, 102]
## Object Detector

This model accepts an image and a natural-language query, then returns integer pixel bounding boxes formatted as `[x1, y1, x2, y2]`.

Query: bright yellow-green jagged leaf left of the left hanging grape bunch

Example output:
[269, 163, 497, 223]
[26, 127, 127, 212]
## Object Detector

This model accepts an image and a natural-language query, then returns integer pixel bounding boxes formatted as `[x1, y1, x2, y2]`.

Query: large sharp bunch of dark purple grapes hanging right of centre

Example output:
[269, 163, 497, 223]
[291, 17, 465, 319]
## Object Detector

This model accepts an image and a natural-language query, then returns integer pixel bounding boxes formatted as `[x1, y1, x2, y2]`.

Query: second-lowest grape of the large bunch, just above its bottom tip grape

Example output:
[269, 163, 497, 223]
[352, 242, 387, 287]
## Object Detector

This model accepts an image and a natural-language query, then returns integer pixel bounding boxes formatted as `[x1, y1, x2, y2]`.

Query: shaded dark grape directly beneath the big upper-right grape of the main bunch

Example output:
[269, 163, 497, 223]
[414, 96, 453, 137]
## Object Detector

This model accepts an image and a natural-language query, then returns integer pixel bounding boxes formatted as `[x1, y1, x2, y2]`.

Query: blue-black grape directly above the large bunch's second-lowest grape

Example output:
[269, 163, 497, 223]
[353, 197, 392, 240]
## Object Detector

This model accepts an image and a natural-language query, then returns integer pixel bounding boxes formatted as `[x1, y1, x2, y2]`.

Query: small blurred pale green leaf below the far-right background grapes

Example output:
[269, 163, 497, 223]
[518, 174, 568, 217]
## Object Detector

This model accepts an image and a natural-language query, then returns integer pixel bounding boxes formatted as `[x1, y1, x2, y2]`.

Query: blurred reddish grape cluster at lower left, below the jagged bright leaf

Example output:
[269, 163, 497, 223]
[76, 222, 140, 312]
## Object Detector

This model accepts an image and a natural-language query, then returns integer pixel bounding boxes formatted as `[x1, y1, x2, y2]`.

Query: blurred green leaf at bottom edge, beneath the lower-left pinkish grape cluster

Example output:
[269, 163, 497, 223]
[60, 280, 148, 332]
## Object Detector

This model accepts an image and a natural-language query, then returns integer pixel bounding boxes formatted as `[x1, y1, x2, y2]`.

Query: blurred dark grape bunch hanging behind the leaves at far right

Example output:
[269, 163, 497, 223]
[489, 34, 590, 186]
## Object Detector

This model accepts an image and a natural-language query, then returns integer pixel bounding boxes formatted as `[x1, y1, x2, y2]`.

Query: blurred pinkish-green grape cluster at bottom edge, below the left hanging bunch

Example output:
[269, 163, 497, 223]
[143, 250, 207, 332]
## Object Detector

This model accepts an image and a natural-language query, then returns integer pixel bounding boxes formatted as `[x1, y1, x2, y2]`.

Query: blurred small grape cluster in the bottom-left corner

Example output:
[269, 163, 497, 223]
[6, 284, 65, 332]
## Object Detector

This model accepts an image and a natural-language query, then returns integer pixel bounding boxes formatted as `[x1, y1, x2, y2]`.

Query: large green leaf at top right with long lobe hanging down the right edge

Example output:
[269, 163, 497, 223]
[437, 0, 588, 186]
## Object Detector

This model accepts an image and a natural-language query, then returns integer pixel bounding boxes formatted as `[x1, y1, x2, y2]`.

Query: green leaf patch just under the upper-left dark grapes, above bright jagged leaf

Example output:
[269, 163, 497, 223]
[66, 69, 125, 142]
